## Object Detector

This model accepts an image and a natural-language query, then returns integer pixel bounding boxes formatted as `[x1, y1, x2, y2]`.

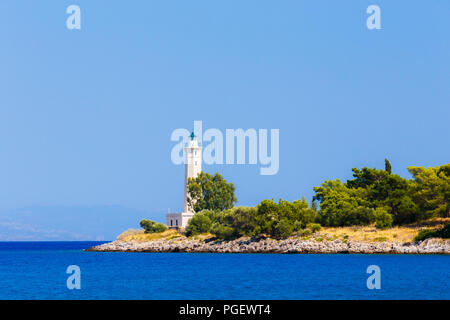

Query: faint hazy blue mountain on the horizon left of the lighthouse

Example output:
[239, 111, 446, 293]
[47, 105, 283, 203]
[0, 206, 165, 241]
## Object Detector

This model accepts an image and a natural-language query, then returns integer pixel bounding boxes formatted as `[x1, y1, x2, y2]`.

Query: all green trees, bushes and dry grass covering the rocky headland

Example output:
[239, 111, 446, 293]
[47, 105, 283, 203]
[141, 159, 450, 241]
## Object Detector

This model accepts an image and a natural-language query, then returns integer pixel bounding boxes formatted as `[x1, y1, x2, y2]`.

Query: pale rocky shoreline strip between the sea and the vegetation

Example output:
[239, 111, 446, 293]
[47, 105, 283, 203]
[85, 238, 450, 254]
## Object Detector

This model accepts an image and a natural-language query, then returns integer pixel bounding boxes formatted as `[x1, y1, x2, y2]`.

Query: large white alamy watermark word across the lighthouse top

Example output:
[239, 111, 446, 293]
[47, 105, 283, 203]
[170, 121, 280, 175]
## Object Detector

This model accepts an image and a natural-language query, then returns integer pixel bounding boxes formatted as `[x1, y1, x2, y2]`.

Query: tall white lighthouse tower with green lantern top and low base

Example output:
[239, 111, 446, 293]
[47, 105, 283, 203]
[166, 132, 202, 228]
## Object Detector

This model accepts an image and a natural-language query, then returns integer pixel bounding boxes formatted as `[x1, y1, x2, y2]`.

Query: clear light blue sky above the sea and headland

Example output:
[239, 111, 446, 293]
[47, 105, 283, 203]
[0, 0, 450, 239]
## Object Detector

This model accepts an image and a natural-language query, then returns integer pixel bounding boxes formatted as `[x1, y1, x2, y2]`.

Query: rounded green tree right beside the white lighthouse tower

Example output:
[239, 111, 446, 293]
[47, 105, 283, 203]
[188, 172, 237, 212]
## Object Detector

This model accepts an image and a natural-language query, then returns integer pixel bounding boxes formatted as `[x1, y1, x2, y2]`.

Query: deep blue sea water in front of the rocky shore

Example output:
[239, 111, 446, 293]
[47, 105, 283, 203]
[0, 242, 450, 300]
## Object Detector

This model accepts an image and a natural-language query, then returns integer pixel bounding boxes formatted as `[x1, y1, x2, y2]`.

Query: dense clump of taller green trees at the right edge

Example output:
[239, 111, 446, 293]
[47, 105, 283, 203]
[313, 159, 450, 228]
